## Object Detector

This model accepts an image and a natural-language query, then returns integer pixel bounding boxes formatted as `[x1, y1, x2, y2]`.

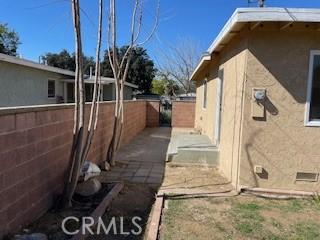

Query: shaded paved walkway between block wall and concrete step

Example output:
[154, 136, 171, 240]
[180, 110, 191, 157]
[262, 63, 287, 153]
[100, 127, 171, 187]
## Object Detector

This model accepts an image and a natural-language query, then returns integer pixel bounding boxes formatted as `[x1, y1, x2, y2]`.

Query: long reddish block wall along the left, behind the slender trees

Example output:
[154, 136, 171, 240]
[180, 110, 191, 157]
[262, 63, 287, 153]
[0, 101, 147, 236]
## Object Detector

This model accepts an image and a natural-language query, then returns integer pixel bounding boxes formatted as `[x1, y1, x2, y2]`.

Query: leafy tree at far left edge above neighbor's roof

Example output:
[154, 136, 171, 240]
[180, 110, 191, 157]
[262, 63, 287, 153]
[0, 23, 20, 56]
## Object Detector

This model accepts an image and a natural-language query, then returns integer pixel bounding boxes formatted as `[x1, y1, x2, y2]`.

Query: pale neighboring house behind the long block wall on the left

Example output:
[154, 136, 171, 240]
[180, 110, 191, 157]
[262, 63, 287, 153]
[0, 53, 138, 107]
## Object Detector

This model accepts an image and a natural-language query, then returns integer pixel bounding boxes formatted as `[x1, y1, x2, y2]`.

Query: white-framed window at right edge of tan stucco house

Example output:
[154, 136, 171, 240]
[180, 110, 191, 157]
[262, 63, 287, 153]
[304, 50, 320, 126]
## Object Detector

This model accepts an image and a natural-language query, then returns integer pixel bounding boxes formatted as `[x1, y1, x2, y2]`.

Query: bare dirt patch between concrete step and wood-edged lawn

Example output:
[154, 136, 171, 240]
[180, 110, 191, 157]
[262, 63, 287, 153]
[160, 163, 233, 194]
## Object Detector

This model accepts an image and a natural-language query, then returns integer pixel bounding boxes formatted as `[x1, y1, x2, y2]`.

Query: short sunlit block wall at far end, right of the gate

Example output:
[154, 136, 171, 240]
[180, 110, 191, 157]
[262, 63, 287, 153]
[171, 101, 196, 128]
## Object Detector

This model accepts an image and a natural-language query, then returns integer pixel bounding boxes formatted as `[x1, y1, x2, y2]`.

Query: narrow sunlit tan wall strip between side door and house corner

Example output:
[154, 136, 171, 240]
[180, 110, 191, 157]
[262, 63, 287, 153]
[218, 38, 247, 185]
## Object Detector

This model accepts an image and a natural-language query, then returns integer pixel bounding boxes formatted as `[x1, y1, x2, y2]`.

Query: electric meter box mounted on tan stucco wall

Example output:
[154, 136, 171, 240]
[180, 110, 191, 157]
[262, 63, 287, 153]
[251, 88, 267, 118]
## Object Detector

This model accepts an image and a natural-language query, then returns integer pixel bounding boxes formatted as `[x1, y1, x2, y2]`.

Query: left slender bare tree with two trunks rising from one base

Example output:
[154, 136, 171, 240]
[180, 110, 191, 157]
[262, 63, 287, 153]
[62, 0, 103, 208]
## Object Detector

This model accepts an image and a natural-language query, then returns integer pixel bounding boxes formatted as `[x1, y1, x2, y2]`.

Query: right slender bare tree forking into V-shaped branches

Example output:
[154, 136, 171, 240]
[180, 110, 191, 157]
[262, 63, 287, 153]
[106, 0, 160, 165]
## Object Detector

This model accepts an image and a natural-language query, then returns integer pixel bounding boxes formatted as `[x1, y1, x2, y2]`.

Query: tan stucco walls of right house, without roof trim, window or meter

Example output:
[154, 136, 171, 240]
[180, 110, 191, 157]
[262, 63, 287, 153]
[196, 23, 320, 191]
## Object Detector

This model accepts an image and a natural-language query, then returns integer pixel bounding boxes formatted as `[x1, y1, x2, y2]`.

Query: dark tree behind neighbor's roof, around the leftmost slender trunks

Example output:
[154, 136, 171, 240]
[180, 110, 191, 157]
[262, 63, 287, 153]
[41, 49, 95, 74]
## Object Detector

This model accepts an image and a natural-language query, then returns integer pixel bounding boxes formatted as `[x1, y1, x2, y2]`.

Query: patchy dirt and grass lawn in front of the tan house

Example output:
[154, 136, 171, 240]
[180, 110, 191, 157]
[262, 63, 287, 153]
[160, 195, 320, 240]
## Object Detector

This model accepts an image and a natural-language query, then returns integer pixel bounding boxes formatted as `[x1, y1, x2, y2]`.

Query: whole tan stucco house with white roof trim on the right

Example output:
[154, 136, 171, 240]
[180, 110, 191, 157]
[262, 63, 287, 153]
[192, 8, 320, 191]
